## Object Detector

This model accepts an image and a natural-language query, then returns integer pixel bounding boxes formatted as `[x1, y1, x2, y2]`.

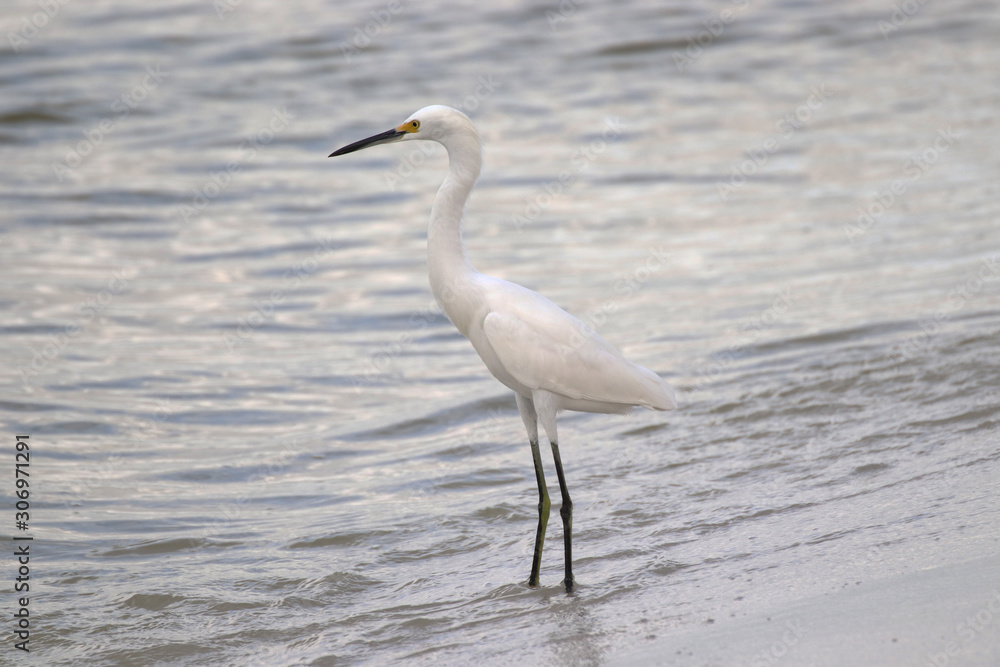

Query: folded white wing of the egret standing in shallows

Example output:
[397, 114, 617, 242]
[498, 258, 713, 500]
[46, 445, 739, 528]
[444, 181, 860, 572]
[483, 298, 675, 410]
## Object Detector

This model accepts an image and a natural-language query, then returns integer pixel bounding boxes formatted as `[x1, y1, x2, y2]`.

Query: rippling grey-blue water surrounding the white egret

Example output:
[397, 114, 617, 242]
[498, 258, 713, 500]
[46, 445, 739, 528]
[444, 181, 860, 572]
[0, 0, 1000, 665]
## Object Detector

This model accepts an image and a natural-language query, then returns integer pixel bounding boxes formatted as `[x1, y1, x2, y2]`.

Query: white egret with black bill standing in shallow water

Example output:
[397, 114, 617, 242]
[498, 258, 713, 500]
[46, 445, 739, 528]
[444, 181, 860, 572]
[329, 105, 677, 592]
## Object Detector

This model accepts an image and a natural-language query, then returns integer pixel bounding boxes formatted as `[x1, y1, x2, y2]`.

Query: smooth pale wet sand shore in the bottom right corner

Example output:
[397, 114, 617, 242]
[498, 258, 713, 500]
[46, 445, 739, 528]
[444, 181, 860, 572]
[610, 557, 1000, 667]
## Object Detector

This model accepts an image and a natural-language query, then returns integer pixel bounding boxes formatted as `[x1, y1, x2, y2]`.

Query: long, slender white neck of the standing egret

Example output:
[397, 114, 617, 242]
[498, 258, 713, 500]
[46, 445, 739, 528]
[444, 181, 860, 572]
[427, 135, 482, 336]
